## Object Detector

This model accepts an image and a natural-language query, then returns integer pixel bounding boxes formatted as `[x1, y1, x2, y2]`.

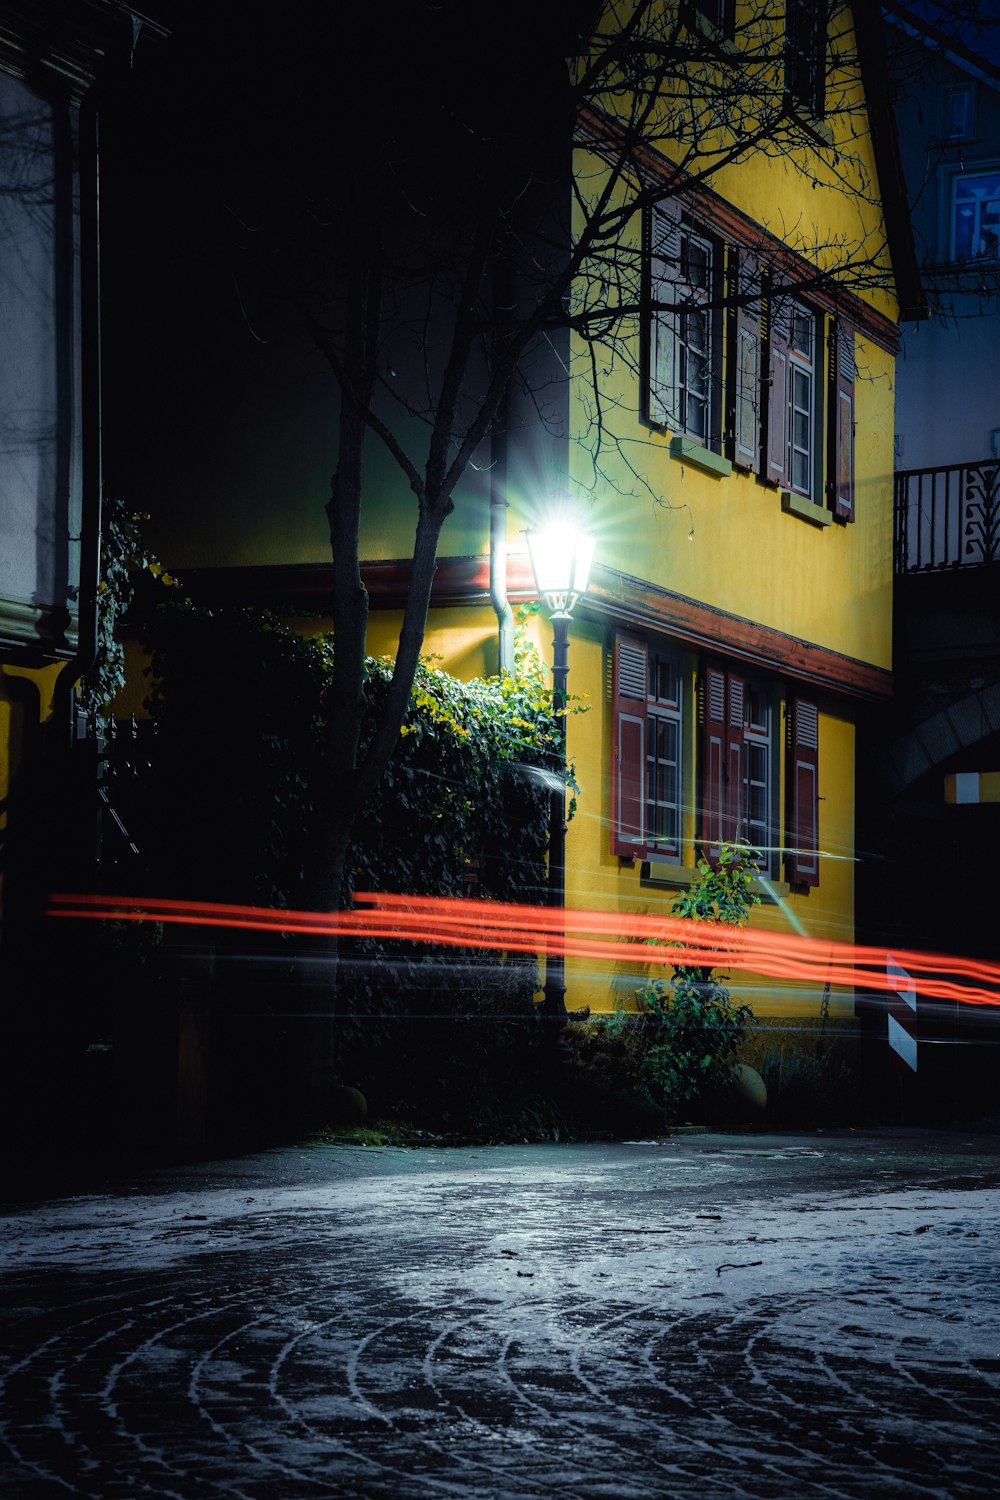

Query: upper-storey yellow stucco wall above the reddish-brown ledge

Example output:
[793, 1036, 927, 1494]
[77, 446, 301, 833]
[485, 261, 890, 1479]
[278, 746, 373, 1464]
[554, 0, 898, 668]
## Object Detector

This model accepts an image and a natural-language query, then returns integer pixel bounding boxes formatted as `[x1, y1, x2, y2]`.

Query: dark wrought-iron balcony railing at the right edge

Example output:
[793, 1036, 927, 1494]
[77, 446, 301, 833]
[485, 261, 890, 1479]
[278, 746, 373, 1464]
[894, 459, 1000, 573]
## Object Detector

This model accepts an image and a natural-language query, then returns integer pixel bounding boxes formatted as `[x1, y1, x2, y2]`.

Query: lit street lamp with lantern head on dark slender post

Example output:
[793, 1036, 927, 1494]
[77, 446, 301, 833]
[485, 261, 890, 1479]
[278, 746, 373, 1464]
[525, 518, 594, 1059]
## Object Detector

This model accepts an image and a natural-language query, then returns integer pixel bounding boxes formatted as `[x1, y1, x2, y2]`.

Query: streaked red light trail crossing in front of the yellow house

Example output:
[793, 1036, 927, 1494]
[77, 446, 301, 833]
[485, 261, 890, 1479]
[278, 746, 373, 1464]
[48, 893, 1000, 1007]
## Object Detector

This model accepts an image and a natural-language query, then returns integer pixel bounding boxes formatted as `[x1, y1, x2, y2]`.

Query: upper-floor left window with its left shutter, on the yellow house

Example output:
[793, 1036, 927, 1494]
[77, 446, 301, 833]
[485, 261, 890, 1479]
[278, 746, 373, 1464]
[646, 203, 721, 449]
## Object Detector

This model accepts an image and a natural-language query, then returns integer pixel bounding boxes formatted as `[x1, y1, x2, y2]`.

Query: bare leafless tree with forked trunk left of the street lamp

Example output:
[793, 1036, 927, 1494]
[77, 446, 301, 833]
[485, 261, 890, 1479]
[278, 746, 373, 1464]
[119, 0, 917, 906]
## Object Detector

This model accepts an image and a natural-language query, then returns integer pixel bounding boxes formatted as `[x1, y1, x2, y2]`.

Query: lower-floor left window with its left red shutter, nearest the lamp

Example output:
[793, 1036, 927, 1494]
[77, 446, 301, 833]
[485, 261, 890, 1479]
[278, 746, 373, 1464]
[612, 636, 684, 861]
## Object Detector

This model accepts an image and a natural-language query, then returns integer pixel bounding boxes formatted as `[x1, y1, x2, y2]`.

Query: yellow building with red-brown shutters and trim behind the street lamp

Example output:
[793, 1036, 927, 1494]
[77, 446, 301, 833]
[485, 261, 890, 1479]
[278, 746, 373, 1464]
[353, 5, 921, 1017]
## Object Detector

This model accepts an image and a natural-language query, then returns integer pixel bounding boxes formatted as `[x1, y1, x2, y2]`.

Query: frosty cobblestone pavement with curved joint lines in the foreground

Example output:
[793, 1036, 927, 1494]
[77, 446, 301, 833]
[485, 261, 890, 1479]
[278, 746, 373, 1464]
[0, 1133, 1000, 1500]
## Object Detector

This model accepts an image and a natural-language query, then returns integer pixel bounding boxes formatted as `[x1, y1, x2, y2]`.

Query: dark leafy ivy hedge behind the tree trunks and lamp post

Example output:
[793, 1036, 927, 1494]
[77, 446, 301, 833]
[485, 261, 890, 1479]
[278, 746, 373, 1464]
[117, 591, 573, 1136]
